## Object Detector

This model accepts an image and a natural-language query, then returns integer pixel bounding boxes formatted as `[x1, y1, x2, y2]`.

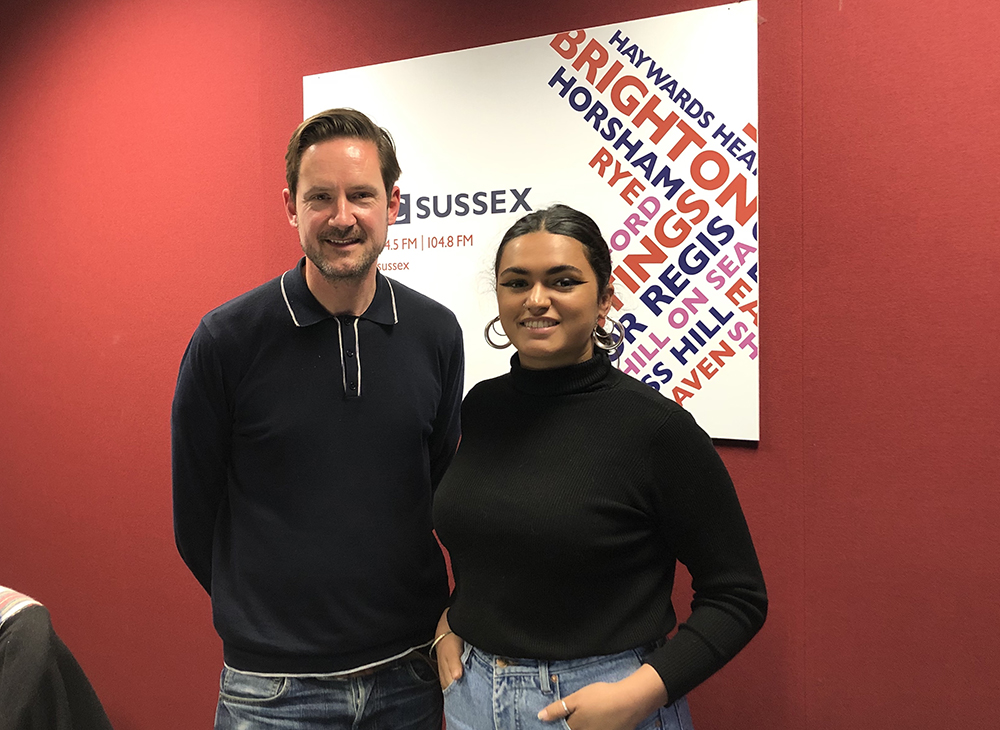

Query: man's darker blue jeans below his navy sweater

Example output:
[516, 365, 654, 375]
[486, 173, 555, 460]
[215, 654, 441, 730]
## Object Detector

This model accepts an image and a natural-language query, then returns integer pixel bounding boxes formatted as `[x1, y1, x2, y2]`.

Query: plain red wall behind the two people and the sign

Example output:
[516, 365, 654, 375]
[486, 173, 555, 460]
[0, 0, 1000, 730]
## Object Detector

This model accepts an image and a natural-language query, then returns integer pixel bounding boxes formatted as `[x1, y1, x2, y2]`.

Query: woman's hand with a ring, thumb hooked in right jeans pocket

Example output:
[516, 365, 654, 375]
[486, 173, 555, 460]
[538, 664, 668, 730]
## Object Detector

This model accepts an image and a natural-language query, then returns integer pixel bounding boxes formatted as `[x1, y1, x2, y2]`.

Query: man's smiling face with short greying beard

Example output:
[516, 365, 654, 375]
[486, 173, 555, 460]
[284, 137, 399, 282]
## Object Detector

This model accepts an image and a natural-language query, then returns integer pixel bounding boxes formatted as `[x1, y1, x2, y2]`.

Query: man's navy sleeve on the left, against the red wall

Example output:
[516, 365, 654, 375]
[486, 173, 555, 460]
[170, 322, 232, 595]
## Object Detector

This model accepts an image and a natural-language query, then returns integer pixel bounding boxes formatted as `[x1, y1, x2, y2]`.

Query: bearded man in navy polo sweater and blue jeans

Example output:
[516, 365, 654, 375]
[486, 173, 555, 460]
[172, 109, 464, 730]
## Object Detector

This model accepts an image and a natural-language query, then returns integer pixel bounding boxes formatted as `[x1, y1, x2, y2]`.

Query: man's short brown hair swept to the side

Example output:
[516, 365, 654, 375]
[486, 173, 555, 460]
[285, 108, 402, 200]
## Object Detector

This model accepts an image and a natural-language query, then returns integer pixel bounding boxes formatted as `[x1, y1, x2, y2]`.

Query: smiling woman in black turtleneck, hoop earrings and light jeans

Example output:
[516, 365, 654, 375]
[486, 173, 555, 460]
[434, 205, 767, 730]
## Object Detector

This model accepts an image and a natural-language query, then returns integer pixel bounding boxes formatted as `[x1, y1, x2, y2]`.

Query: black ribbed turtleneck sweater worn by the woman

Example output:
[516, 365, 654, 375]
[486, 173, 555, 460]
[434, 353, 767, 701]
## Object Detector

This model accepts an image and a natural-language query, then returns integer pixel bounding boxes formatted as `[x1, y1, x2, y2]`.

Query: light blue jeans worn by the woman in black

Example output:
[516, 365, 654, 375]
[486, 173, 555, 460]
[444, 642, 694, 730]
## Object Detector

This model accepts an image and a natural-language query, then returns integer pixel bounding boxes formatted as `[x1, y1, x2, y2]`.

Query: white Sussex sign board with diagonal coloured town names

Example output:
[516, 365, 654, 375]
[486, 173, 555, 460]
[303, 0, 759, 440]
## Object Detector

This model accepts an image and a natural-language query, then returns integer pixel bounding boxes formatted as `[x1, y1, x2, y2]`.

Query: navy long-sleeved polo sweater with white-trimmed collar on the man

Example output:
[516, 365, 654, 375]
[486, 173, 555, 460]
[171, 259, 463, 674]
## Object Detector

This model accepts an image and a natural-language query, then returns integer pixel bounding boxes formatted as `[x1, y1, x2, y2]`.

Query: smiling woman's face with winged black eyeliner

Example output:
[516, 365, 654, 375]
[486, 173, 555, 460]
[497, 231, 611, 370]
